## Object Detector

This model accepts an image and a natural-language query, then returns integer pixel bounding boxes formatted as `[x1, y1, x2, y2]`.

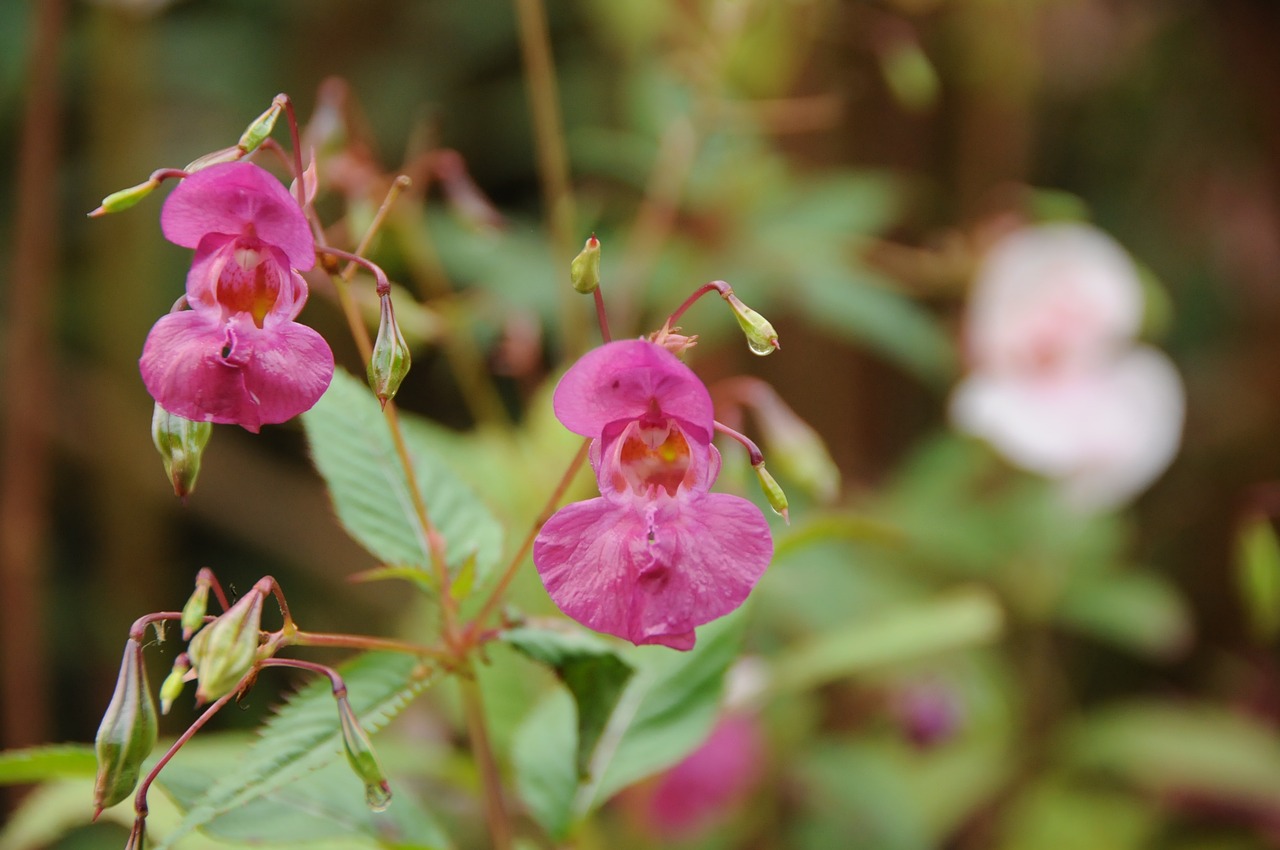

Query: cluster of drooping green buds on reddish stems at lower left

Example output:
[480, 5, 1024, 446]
[93, 568, 392, 847]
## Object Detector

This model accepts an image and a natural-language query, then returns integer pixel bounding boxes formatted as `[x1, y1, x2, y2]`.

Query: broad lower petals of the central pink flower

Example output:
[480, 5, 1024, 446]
[534, 493, 773, 649]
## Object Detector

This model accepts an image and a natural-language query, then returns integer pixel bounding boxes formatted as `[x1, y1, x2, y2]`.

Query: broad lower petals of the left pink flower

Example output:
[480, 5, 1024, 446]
[138, 310, 333, 433]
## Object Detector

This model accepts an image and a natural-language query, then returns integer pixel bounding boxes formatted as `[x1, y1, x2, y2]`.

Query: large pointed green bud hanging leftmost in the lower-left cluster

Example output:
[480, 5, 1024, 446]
[93, 638, 159, 819]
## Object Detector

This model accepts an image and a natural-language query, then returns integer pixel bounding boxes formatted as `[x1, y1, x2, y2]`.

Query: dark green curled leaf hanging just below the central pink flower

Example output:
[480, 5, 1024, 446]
[503, 629, 635, 778]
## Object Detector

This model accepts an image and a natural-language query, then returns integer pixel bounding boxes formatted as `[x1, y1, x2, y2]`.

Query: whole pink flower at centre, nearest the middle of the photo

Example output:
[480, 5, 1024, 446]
[534, 339, 773, 649]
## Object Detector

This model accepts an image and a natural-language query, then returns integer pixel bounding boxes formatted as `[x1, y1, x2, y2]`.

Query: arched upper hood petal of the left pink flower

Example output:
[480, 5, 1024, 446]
[160, 163, 315, 271]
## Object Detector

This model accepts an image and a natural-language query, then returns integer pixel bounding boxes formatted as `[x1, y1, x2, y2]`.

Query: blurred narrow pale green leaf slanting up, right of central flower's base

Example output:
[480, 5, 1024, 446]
[771, 588, 1004, 690]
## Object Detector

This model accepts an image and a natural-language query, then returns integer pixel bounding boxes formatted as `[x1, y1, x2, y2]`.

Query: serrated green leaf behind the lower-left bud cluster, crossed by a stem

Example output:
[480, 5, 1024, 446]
[156, 653, 435, 850]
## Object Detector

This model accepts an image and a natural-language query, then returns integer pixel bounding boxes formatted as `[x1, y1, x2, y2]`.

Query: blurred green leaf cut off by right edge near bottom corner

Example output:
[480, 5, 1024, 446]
[1065, 703, 1280, 810]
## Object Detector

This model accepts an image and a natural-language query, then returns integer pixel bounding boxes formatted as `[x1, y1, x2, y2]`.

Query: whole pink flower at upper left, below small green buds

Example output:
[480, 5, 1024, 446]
[140, 163, 333, 431]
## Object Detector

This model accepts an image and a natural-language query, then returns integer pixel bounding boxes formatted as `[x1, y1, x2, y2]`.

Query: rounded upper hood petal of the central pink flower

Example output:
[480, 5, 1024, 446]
[553, 339, 716, 445]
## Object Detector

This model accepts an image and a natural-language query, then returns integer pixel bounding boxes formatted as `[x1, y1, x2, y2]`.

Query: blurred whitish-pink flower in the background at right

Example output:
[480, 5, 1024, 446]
[951, 225, 1184, 509]
